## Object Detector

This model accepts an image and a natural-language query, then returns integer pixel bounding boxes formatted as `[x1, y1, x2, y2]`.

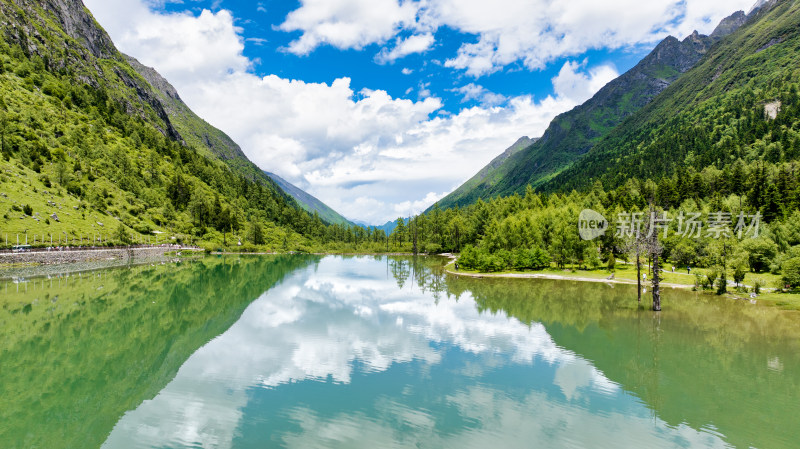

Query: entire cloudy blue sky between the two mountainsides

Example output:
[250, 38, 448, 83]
[84, 0, 752, 224]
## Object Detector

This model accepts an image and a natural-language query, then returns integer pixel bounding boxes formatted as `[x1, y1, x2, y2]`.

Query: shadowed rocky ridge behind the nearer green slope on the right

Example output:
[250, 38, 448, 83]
[439, 8, 744, 207]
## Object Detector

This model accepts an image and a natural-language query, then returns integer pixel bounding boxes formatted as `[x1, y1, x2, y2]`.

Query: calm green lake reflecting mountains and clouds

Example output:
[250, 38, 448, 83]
[0, 256, 800, 449]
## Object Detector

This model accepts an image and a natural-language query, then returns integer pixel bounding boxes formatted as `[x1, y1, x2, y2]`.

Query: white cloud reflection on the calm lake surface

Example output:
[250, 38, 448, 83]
[104, 257, 736, 448]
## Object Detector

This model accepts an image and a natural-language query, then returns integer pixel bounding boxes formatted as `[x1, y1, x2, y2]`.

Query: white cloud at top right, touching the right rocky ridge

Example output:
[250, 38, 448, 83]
[426, 0, 751, 76]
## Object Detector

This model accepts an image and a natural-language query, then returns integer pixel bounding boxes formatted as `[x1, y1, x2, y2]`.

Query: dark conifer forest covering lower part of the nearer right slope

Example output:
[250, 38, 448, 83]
[543, 80, 800, 195]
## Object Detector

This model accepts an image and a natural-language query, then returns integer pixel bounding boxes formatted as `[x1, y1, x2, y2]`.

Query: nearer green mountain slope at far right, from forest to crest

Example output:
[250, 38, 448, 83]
[544, 0, 800, 193]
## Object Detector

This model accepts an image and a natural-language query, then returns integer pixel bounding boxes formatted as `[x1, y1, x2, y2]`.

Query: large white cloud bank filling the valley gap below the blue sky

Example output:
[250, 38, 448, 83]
[86, 0, 615, 224]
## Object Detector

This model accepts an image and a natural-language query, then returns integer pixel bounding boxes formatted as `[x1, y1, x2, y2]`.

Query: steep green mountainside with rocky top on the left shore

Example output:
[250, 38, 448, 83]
[0, 0, 325, 249]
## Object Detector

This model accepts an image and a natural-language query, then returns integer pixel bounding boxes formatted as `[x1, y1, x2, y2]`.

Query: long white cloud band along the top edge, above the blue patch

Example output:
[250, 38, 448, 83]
[281, 0, 753, 76]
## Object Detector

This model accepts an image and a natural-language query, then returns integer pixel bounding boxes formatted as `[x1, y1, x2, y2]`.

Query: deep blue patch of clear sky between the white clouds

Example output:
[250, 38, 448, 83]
[156, 0, 652, 114]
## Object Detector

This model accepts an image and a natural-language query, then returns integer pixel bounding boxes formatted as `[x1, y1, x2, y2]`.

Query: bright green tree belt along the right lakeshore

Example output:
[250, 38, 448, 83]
[391, 161, 800, 285]
